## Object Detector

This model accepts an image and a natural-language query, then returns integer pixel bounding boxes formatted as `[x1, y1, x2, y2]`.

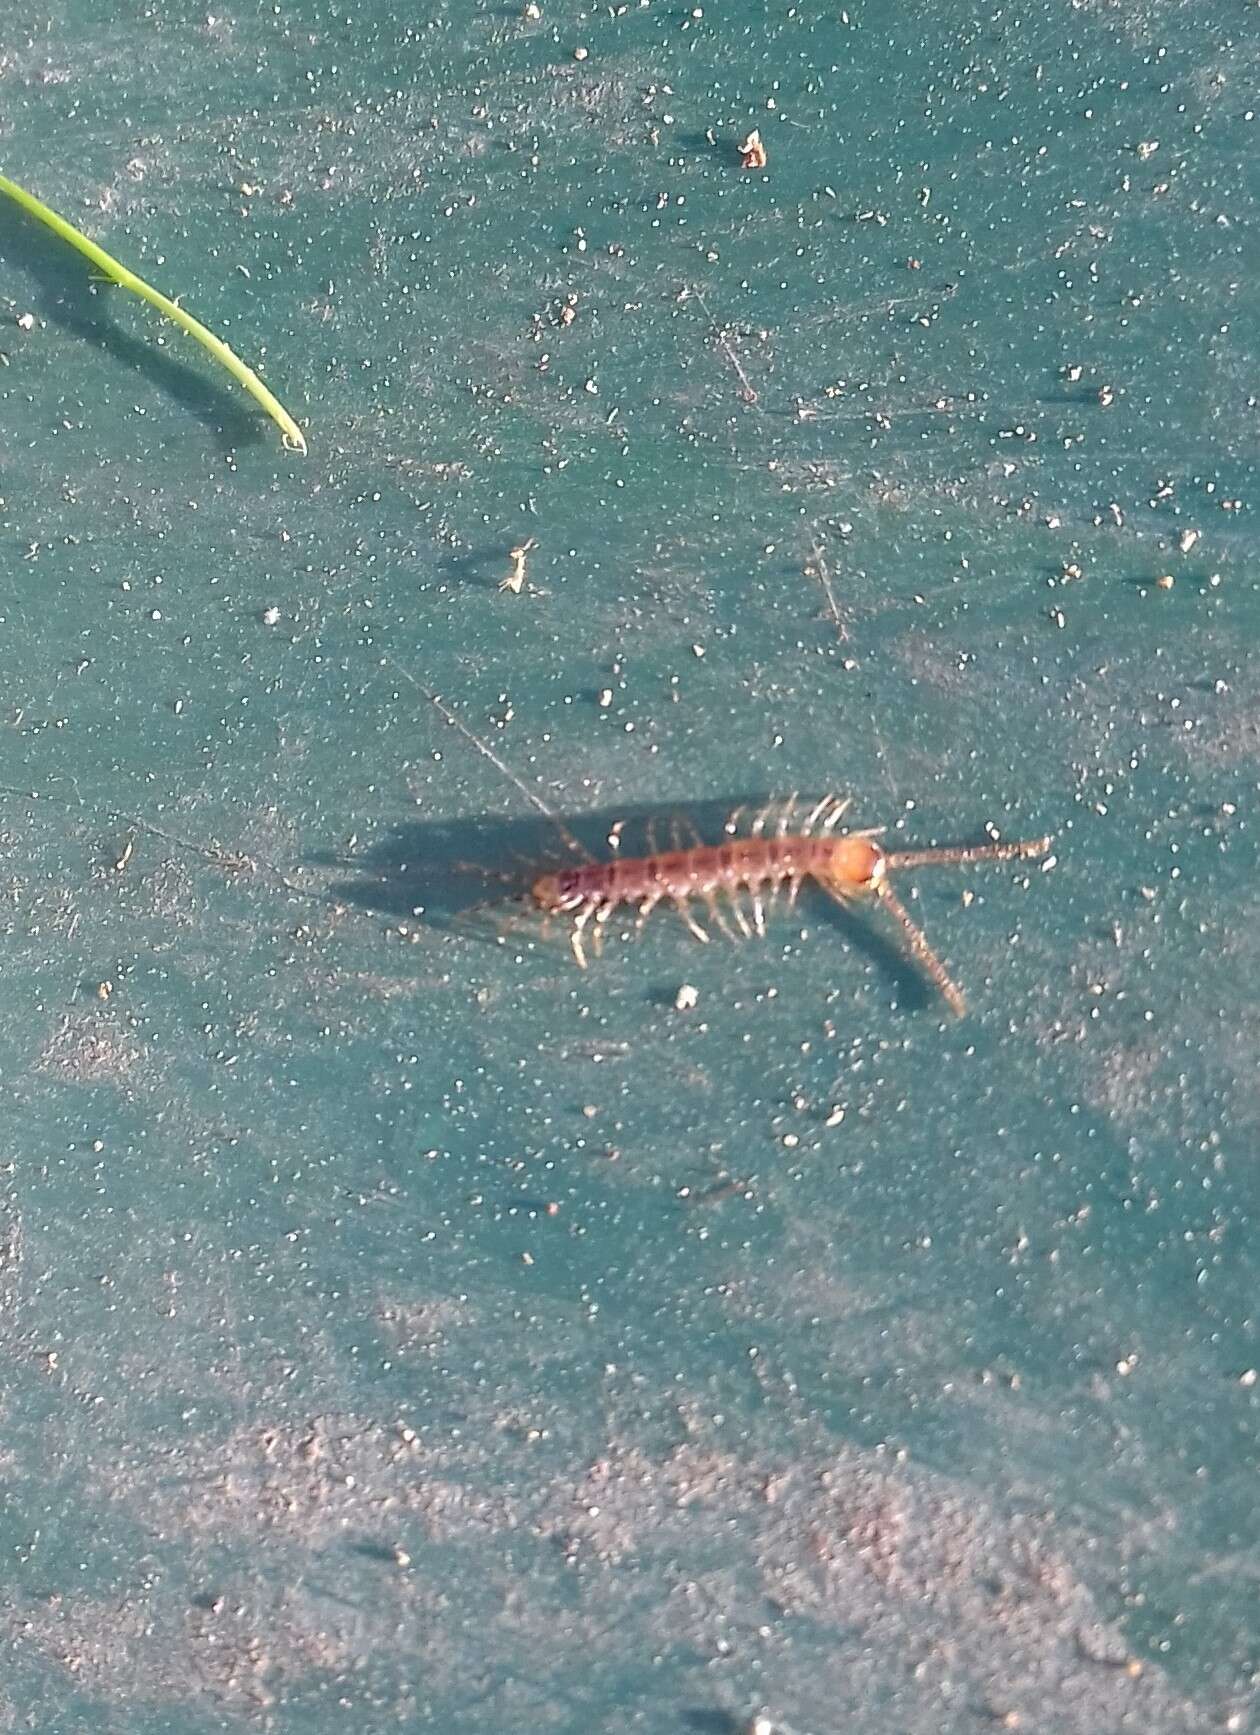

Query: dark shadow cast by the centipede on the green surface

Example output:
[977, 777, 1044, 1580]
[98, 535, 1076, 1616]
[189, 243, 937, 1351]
[321, 795, 932, 1006]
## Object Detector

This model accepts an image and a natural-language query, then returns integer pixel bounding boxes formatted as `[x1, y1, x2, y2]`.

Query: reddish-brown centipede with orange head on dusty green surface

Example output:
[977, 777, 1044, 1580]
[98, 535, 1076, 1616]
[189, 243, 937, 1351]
[531, 795, 1050, 1017]
